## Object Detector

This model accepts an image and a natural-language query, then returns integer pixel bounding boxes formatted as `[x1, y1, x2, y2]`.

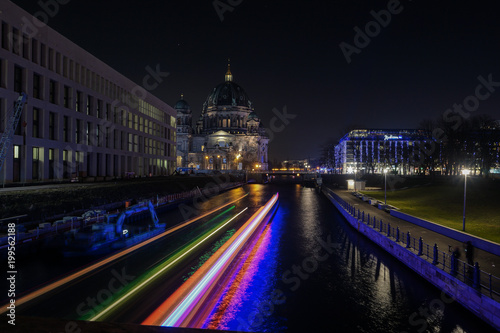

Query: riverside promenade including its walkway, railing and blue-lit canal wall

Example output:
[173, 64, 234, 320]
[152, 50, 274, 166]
[323, 187, 500, 330]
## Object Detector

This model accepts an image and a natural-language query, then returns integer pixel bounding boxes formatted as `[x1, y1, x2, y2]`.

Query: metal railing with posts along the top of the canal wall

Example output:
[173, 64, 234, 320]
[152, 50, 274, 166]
[326, 188, 500, 300]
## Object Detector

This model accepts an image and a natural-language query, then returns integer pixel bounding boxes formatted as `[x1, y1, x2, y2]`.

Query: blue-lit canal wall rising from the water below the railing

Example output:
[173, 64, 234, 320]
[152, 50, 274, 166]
[323, 189, 500, 330]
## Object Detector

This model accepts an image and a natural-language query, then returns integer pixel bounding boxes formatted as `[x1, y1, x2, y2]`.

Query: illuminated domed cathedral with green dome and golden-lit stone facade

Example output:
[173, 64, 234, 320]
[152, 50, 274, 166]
[174, 65, 269, 171]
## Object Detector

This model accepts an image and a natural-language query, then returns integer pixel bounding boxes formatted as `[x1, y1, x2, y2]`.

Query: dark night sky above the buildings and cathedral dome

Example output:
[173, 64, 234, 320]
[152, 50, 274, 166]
[9, 0, 500, 160]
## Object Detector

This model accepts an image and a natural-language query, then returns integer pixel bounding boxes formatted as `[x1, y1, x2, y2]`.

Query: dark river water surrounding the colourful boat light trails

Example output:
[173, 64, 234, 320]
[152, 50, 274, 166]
[6, 184, 494, 333]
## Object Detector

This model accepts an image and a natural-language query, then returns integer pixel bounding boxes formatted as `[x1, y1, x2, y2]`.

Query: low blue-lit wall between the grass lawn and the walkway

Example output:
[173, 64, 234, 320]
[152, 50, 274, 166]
[391, 210, 500, 256]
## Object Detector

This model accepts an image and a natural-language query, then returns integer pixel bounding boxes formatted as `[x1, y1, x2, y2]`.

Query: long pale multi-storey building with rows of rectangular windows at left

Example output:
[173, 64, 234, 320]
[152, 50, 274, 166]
[0, 0, 176, 183]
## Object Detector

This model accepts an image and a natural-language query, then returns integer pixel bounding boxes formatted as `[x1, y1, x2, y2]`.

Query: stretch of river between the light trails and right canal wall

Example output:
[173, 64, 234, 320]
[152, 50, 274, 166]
[222, 185, 493, 332]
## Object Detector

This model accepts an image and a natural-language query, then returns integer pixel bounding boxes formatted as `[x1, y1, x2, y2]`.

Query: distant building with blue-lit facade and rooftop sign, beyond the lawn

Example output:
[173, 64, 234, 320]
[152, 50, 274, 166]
[334, 129, 432, 174]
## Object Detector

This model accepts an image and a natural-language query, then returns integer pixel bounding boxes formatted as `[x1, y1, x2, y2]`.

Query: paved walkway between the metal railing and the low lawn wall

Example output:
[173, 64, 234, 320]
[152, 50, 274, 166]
[333, 189, 500, 286]
